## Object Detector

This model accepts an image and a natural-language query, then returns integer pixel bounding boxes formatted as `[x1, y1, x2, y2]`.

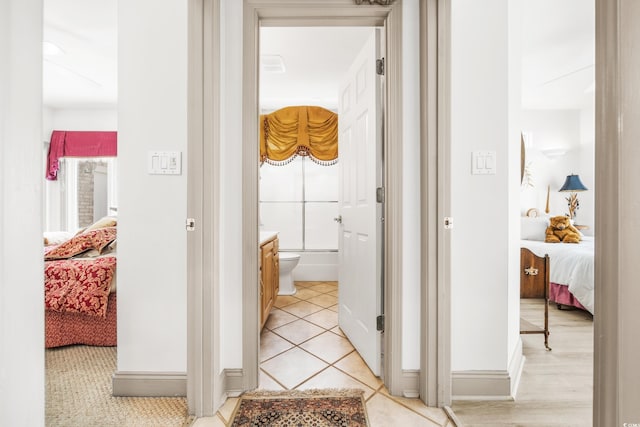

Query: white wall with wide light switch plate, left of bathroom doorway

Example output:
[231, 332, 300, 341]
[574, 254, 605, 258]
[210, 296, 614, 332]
[117, 0, 188, 372]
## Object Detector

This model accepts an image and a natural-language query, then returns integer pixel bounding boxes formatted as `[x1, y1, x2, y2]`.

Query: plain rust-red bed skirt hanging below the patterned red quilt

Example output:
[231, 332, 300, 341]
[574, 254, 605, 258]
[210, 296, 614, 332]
[44, 292, 117, 348]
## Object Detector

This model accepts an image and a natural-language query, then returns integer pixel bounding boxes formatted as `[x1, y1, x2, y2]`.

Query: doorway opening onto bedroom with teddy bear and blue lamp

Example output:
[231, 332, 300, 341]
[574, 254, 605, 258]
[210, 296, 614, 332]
[512, 1, 604, 423]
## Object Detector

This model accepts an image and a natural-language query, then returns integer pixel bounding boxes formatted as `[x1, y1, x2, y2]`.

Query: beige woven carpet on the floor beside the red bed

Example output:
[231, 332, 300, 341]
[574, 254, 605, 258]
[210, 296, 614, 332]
[45, 346, 193, 427]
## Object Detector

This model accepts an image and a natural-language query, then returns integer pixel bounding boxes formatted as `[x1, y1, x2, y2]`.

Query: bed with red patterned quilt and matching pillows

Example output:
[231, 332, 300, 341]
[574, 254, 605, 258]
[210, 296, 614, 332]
[44, 222, 117, 348]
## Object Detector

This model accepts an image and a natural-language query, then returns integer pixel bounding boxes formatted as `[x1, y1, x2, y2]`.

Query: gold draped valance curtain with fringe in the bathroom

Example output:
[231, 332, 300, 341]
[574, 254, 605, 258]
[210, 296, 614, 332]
[260, 106, 338, 165]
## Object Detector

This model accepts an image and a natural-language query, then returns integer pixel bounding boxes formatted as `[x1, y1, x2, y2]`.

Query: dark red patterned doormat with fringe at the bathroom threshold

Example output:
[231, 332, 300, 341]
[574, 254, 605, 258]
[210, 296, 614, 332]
[230, 389, 369, 427]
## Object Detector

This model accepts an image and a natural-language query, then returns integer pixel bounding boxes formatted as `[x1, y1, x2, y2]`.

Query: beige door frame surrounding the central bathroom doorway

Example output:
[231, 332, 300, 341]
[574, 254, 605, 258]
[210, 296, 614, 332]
[242, 0, 402, 394]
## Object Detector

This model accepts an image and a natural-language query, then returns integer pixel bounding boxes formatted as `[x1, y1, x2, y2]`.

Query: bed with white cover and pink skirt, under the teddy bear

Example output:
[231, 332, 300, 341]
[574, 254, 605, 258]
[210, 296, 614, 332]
[520, 217, 595, 314]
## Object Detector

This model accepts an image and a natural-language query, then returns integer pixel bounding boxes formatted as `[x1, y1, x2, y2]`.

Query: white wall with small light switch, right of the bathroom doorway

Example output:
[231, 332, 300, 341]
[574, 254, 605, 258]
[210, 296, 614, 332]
[451, 0, 519, 372]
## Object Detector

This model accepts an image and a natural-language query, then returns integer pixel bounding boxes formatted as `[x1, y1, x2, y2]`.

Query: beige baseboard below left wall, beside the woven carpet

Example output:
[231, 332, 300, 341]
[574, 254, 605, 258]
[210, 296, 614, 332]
[112, 372, 187, 397]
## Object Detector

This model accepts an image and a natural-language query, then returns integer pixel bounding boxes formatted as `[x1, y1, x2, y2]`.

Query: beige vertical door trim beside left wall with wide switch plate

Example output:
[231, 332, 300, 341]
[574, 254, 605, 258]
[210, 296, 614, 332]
[187, 0, 225, 417]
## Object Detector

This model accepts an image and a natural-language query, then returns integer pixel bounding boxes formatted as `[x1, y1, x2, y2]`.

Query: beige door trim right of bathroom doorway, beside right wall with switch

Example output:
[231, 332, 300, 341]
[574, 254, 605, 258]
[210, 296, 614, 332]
[419, 0, 451, 407]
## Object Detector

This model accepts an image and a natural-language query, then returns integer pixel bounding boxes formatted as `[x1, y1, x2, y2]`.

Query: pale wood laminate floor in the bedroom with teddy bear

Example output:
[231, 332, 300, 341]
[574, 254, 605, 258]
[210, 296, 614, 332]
[451, 299, 593, 427]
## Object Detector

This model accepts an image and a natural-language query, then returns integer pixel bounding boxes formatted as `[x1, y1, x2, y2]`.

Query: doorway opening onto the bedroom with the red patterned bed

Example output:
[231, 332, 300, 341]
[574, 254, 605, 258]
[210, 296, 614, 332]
[40, 0, 118, 425]
